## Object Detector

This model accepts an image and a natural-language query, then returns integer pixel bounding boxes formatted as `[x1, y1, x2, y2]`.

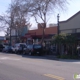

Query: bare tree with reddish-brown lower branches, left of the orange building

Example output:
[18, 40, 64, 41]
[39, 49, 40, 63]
[10, 0, 31, 36]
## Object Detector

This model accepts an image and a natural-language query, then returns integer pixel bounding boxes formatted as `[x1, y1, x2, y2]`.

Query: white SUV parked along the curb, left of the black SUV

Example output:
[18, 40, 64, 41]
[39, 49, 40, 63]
[13, 43, 27, 54]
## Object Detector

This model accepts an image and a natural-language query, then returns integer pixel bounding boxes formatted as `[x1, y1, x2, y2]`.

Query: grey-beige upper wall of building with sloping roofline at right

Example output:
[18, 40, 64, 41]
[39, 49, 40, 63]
[59, 11, 80, 34]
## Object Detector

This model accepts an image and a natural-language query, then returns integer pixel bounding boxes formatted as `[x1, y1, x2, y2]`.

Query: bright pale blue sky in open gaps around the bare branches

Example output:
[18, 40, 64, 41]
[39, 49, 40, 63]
[0, 0, 80, 36]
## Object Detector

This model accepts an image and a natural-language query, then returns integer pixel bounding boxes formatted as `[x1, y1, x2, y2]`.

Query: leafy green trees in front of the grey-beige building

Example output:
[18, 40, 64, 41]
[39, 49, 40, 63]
[52, 34, 77, 56]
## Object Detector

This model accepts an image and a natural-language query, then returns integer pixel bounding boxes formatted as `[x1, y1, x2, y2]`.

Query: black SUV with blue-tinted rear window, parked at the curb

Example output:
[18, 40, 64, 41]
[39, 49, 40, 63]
[29, 44, 43, 55]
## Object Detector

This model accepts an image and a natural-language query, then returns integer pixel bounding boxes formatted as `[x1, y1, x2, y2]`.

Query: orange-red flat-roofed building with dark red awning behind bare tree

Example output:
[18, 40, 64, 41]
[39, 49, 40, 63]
[24, 23, 57, 42]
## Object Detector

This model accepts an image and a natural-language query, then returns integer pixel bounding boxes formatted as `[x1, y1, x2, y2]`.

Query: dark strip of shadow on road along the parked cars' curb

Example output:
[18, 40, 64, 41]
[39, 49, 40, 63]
[1, 52, 80, 62]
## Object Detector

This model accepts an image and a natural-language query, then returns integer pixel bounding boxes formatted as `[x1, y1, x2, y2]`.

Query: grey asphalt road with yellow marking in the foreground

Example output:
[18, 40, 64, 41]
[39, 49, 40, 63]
[0, 53, 80, 80]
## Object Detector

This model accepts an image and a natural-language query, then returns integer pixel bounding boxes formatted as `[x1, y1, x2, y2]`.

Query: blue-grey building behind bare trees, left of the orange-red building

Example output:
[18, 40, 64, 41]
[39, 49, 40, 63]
[6, 25, 28, 45]
